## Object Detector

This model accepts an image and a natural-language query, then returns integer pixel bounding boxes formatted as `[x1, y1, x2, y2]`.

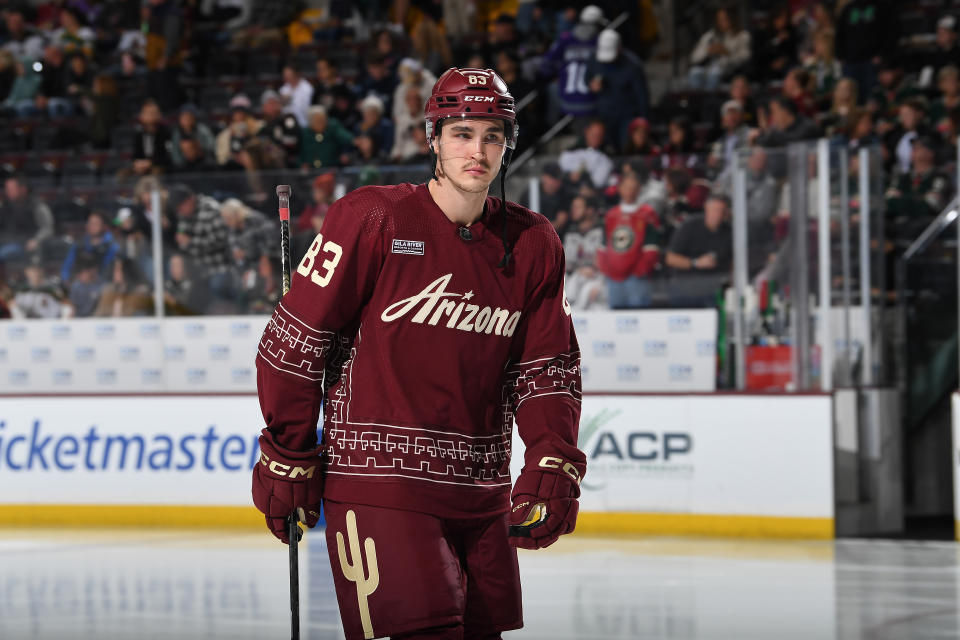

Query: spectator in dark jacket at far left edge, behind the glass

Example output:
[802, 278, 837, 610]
[0, 176, 53, 262]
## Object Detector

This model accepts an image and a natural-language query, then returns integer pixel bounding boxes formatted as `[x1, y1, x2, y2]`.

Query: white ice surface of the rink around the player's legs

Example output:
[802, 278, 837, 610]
[0, 529, 960, 640]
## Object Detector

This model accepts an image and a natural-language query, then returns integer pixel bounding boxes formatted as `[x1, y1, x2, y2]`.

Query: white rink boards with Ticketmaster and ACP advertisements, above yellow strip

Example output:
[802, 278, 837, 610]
[0, 395, 833, 533]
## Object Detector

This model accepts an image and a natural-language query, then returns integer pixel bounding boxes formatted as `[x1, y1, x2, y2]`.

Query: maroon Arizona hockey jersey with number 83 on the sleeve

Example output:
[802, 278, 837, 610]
[257, 184, 584, 517]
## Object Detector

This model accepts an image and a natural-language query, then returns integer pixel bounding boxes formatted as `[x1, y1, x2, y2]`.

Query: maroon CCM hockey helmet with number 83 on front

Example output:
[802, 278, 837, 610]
[423, 67, 519, 149]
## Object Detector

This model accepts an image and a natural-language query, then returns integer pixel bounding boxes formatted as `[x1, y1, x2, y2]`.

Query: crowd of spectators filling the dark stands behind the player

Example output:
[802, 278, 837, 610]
[0, 0, 960, 318]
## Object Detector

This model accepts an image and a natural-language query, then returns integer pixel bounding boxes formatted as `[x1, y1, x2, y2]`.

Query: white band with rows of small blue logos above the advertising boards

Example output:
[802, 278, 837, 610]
[0, 310, 717, 395]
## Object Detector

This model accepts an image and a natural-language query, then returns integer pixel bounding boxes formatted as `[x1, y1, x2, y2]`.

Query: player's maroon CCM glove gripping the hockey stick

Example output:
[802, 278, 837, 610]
[253, 429, 323, 544]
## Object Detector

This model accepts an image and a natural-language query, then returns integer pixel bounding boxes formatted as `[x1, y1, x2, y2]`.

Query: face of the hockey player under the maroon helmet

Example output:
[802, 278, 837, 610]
[434, 119, 507, 193]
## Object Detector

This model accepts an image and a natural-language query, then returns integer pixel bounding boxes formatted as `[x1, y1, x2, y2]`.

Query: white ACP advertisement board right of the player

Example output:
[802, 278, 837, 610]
[512, 395, 834, 535]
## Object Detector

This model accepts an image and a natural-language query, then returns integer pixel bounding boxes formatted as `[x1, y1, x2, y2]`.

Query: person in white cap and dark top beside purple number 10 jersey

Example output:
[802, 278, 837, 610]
[584, 29, 650, 150]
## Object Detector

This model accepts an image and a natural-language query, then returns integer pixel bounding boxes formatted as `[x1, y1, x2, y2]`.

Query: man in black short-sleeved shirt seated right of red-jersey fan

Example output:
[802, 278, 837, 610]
[665, 194, 732, 307]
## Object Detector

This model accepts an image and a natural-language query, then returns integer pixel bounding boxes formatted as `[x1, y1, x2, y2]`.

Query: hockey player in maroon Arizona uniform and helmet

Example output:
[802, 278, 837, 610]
[253, 69, 586, 640]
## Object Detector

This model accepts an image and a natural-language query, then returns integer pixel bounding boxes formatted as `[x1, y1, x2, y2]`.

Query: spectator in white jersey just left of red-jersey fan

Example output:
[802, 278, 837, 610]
[563, 196, 607, 309]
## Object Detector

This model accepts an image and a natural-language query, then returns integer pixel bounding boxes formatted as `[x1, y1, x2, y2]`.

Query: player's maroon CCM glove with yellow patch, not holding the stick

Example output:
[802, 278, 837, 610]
[509, 456, 586, 549]
